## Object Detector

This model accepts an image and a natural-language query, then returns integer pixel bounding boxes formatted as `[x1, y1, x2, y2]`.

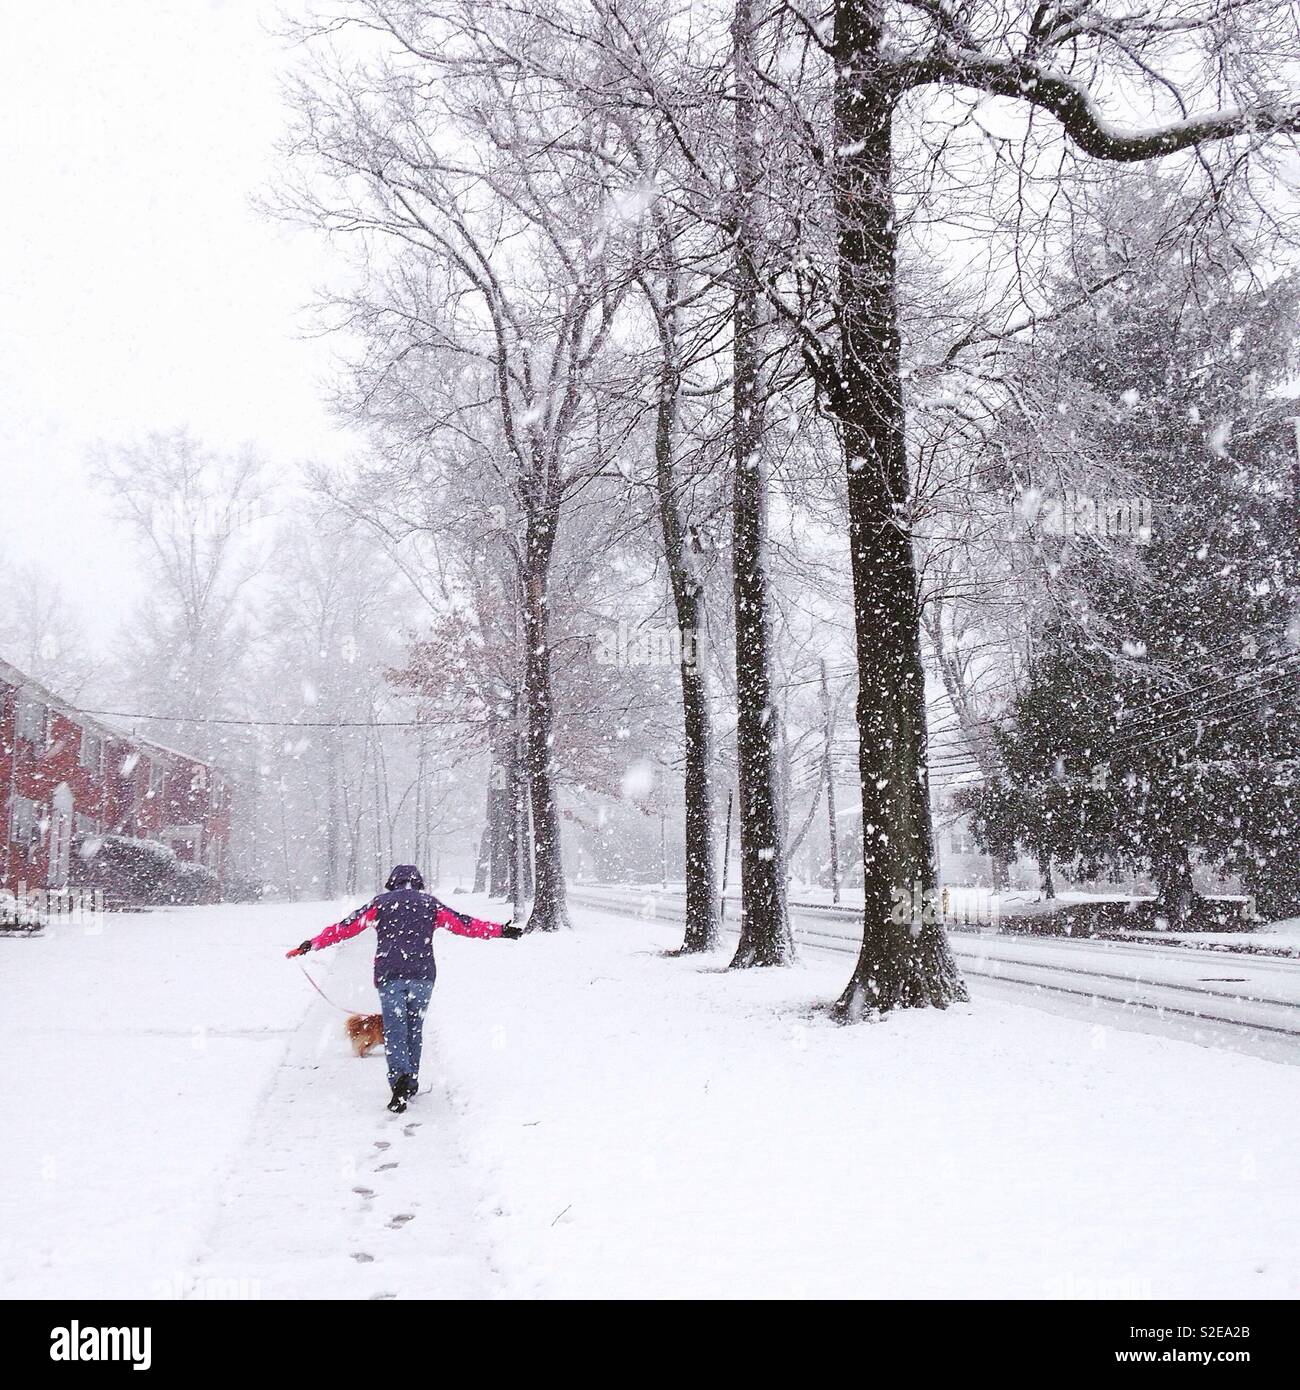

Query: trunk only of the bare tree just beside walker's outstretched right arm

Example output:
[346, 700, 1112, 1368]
[523, 517, 569, 931]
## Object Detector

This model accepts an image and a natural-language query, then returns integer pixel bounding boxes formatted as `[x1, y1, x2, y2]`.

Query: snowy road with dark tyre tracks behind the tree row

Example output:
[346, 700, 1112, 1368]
[570, 885, 1300, 1065]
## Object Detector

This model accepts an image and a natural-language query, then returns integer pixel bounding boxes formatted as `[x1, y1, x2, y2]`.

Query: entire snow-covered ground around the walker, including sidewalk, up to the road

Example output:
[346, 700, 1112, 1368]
[0, 899, 1300, 1298]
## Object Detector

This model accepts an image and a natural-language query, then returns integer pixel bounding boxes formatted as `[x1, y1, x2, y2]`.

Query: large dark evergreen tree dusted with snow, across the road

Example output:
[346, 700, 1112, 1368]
[968, 183, 1300, 922]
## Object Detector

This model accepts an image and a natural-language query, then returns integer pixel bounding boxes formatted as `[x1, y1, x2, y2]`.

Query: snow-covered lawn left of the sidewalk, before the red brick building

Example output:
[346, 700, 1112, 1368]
[0, 905, 347, 1297]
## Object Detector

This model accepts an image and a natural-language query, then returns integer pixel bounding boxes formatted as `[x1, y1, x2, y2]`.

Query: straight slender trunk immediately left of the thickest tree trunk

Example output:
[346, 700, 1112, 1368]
[731, 0, 794, 969]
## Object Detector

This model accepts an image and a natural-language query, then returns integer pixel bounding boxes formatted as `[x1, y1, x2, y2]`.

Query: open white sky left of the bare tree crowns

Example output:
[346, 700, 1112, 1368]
[0, 0, 346, 635]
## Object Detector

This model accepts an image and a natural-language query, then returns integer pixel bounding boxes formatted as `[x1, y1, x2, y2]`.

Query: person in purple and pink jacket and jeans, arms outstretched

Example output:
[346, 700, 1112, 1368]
[285, 865, 523, 1115]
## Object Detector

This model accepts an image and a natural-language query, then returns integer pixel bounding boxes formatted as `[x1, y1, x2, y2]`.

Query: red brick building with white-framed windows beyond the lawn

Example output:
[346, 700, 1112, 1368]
[0, 660, 231, 891]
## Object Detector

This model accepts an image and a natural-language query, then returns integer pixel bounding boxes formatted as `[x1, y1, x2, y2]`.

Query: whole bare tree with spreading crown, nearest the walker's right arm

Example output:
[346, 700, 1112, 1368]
[279, 3, 645, 930]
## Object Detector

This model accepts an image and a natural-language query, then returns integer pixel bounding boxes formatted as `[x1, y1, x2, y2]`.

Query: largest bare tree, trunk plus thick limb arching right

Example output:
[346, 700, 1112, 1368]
[750, 0, 1300, 1020]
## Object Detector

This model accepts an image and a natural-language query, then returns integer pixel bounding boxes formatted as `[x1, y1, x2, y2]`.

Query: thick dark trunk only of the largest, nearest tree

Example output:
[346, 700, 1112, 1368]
[831, 16, 968, 1022]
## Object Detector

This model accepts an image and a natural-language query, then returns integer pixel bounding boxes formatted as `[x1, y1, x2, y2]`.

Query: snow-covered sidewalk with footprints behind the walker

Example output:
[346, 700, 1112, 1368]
[190, 919, 496, 1298]
